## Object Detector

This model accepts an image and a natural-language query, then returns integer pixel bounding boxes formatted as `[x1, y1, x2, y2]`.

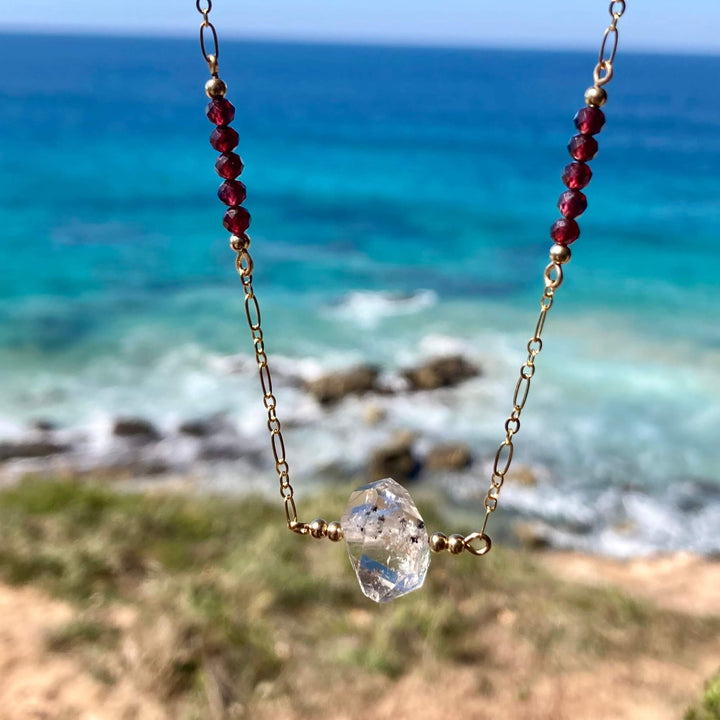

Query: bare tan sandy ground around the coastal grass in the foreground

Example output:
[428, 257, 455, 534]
[0, 553, 720, 720]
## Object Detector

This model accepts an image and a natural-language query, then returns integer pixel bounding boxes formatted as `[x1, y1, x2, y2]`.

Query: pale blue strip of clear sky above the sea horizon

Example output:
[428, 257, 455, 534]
[0, 0, 720, 54]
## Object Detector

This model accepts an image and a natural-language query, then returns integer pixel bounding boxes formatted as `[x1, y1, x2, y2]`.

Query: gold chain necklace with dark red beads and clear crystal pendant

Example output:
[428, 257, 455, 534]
[195, 0, 625, 602]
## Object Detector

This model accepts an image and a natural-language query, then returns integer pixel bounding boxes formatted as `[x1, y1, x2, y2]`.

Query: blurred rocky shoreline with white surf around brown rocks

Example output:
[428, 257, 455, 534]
[0, 353, 720, 557]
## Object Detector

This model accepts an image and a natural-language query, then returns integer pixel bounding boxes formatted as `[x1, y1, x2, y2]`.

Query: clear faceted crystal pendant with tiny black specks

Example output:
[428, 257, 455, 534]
[341, 478, 430, 602]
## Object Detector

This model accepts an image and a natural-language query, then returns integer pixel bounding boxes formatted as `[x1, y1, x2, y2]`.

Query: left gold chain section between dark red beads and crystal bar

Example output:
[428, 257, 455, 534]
[230, 242, 300, 534]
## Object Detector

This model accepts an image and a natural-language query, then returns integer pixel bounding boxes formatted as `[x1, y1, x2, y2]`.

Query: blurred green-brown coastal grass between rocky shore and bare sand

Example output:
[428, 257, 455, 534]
[0, 479, 720, 720]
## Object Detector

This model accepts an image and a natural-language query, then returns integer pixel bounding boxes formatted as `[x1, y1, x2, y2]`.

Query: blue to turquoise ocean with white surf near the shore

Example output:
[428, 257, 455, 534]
[0, 33, 720, 555]
